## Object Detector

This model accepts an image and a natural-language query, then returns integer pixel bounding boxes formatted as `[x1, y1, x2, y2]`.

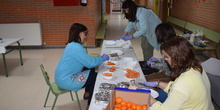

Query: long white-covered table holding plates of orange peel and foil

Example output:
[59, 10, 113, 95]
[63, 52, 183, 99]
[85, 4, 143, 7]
[89, 40, 146, 110]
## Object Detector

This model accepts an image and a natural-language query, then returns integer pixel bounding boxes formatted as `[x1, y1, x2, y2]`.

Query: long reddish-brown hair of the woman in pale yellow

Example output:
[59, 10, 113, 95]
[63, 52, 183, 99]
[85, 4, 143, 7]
[160, 37, 203, 78]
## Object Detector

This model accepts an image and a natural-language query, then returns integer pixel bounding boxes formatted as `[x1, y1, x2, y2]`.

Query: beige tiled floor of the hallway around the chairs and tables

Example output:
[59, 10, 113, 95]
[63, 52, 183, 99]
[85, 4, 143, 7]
[0, 14, 217, 110]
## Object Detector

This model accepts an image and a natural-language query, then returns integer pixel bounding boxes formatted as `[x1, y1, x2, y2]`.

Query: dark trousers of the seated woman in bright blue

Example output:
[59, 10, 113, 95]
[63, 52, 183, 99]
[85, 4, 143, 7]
[83, 68, 97, 105]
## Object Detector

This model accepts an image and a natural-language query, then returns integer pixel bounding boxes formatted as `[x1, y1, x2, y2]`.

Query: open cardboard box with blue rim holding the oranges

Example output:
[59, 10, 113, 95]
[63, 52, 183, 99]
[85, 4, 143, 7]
[104, 87, 150, 110]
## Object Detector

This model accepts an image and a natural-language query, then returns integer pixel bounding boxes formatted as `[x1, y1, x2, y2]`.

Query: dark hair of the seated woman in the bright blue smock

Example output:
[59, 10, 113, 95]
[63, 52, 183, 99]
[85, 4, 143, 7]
[68, 23, 88, 43]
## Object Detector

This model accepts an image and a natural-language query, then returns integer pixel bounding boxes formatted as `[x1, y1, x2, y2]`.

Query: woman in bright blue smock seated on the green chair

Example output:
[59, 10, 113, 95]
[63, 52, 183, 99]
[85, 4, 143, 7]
[55, 23, 109, 108]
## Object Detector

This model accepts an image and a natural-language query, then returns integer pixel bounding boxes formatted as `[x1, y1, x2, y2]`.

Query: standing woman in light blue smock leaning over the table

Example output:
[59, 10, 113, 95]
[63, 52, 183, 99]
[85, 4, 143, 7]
[121, 0, 161, 61]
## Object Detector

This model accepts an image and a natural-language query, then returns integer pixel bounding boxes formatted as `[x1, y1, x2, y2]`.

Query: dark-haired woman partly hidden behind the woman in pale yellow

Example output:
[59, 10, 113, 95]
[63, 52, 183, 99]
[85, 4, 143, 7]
[139, 23, 176, 102]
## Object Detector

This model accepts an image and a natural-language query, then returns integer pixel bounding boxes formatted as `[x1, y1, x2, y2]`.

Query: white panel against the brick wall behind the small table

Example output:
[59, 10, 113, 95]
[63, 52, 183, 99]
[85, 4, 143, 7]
[0, 23, 42, 46]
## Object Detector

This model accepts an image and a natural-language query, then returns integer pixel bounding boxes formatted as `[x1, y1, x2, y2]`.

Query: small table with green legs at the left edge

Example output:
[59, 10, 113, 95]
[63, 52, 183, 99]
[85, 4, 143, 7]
[0, 38, 23, 77]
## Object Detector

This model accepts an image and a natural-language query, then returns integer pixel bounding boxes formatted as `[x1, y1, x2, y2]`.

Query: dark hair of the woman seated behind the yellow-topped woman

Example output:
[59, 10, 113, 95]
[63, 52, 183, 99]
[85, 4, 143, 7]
[155, 23, 176, 44]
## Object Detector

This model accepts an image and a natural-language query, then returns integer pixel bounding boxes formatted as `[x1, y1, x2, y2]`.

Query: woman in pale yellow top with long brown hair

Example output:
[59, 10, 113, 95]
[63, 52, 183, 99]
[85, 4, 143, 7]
[143, 37, 214, 110]
